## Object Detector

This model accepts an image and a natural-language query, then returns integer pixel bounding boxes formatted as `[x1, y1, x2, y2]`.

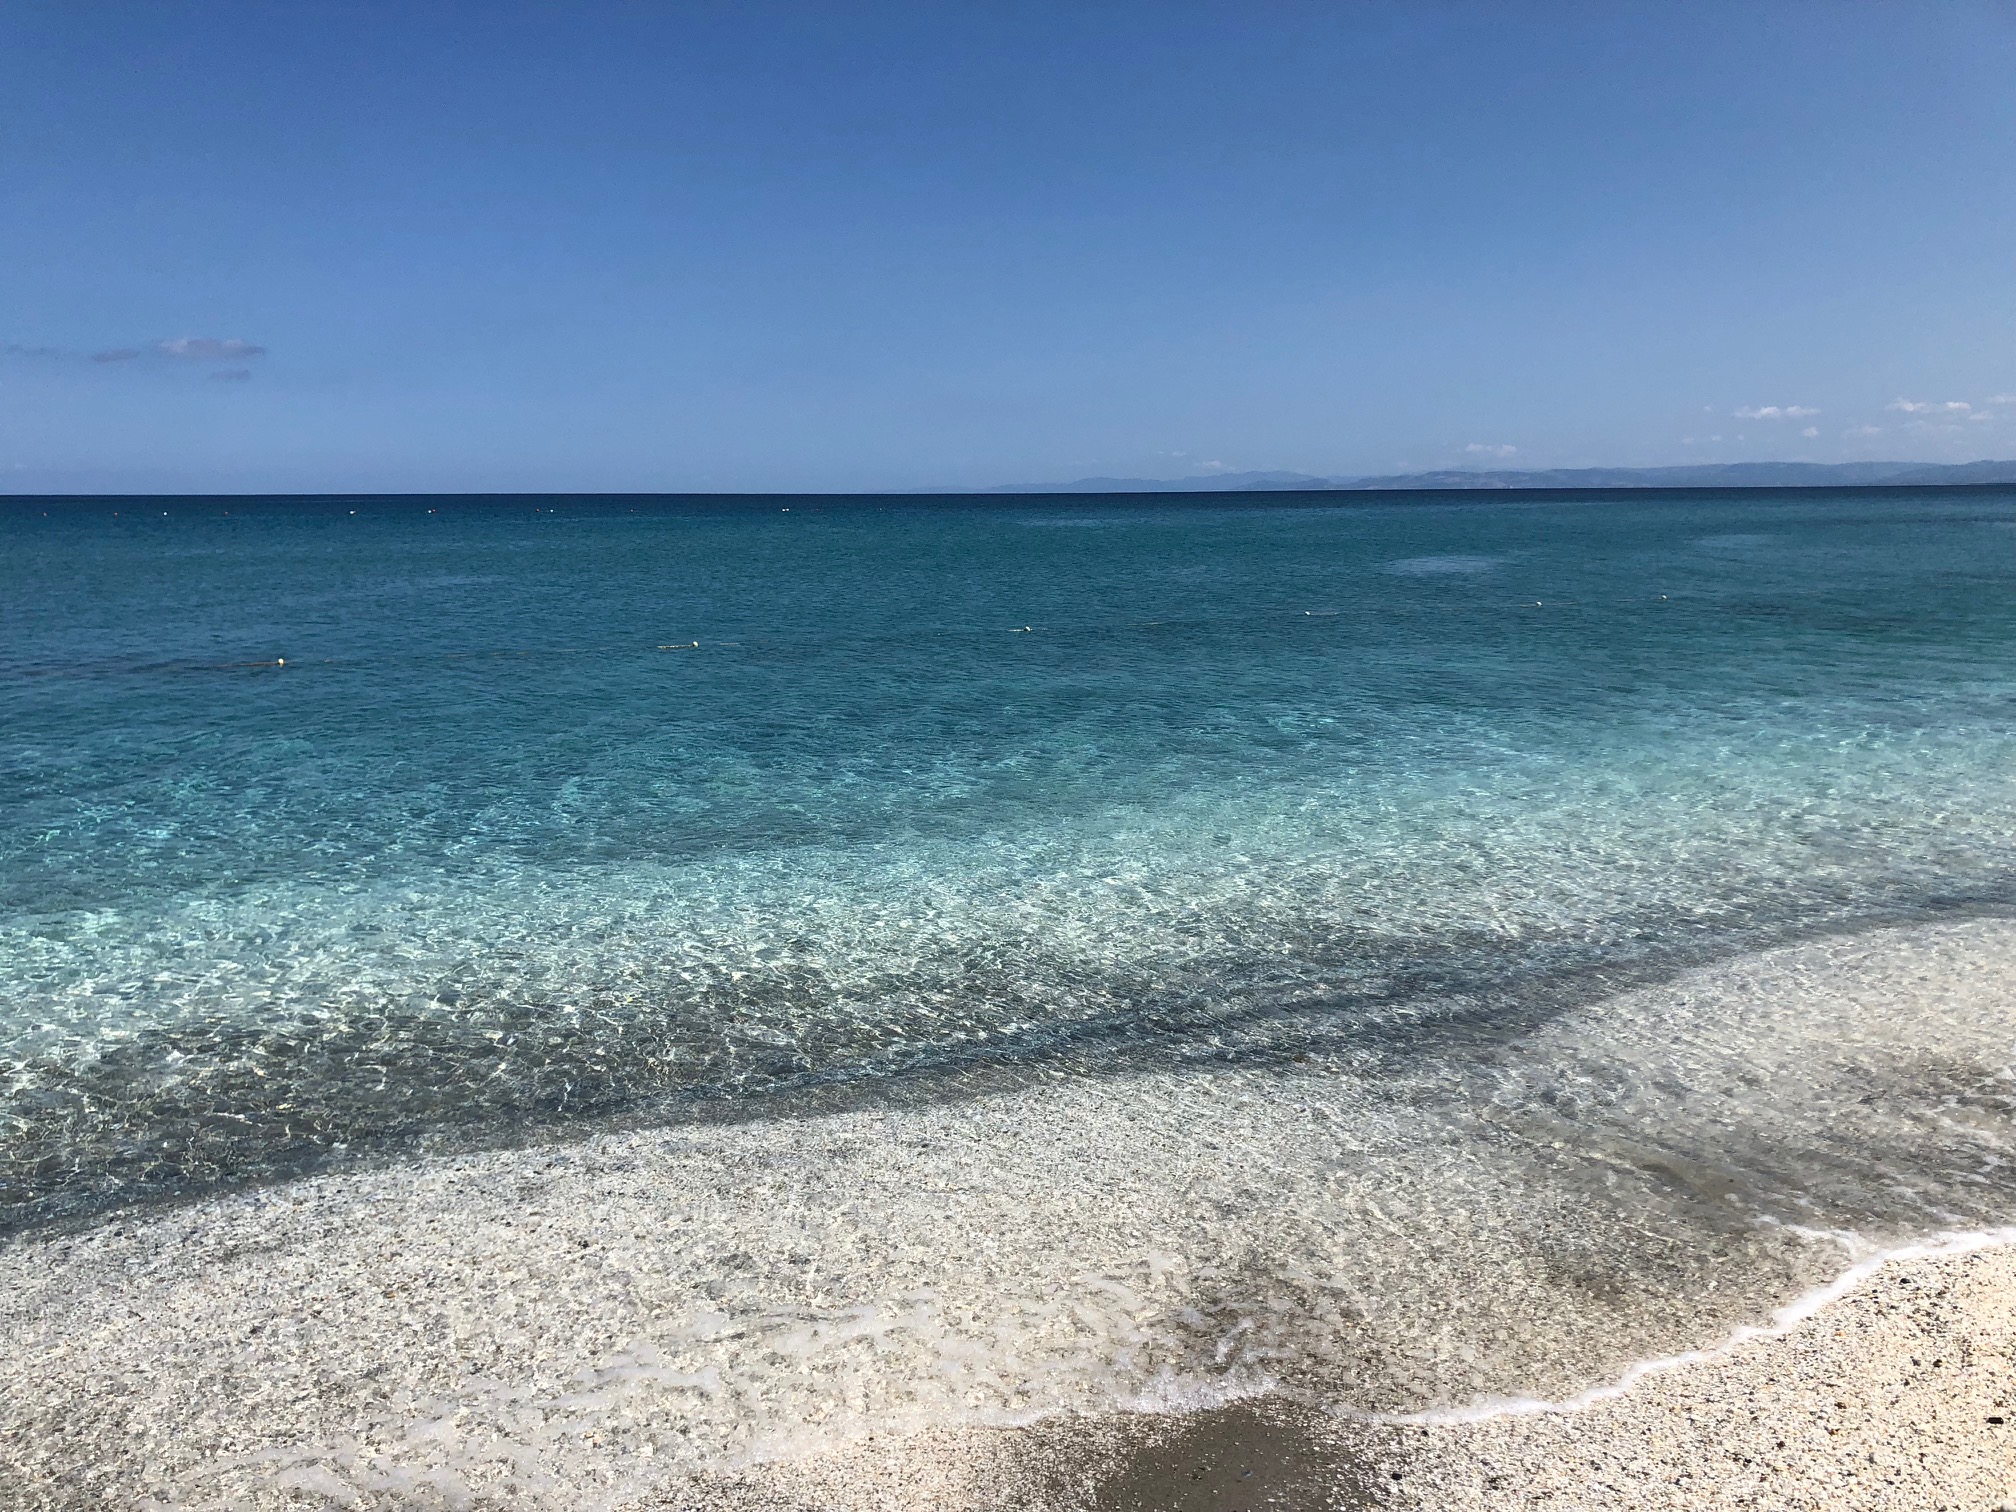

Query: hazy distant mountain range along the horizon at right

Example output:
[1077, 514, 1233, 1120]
[955, 462, 2016, 494]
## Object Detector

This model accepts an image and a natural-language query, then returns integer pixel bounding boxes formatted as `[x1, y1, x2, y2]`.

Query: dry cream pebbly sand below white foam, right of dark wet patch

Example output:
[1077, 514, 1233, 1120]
[1375, 1248, 2016, 1512]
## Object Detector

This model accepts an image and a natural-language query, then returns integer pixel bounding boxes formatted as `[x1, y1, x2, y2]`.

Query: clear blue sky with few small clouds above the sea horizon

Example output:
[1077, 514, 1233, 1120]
[0, 0, 2016, 492]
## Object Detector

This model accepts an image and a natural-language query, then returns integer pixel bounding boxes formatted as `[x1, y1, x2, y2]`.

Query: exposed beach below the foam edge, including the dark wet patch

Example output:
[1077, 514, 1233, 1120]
[733, 1248, 2016, 1512]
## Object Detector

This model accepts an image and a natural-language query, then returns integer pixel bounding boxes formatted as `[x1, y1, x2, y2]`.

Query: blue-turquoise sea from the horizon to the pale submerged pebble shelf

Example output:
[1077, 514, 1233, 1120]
[0, 492, 2016, 1226]
